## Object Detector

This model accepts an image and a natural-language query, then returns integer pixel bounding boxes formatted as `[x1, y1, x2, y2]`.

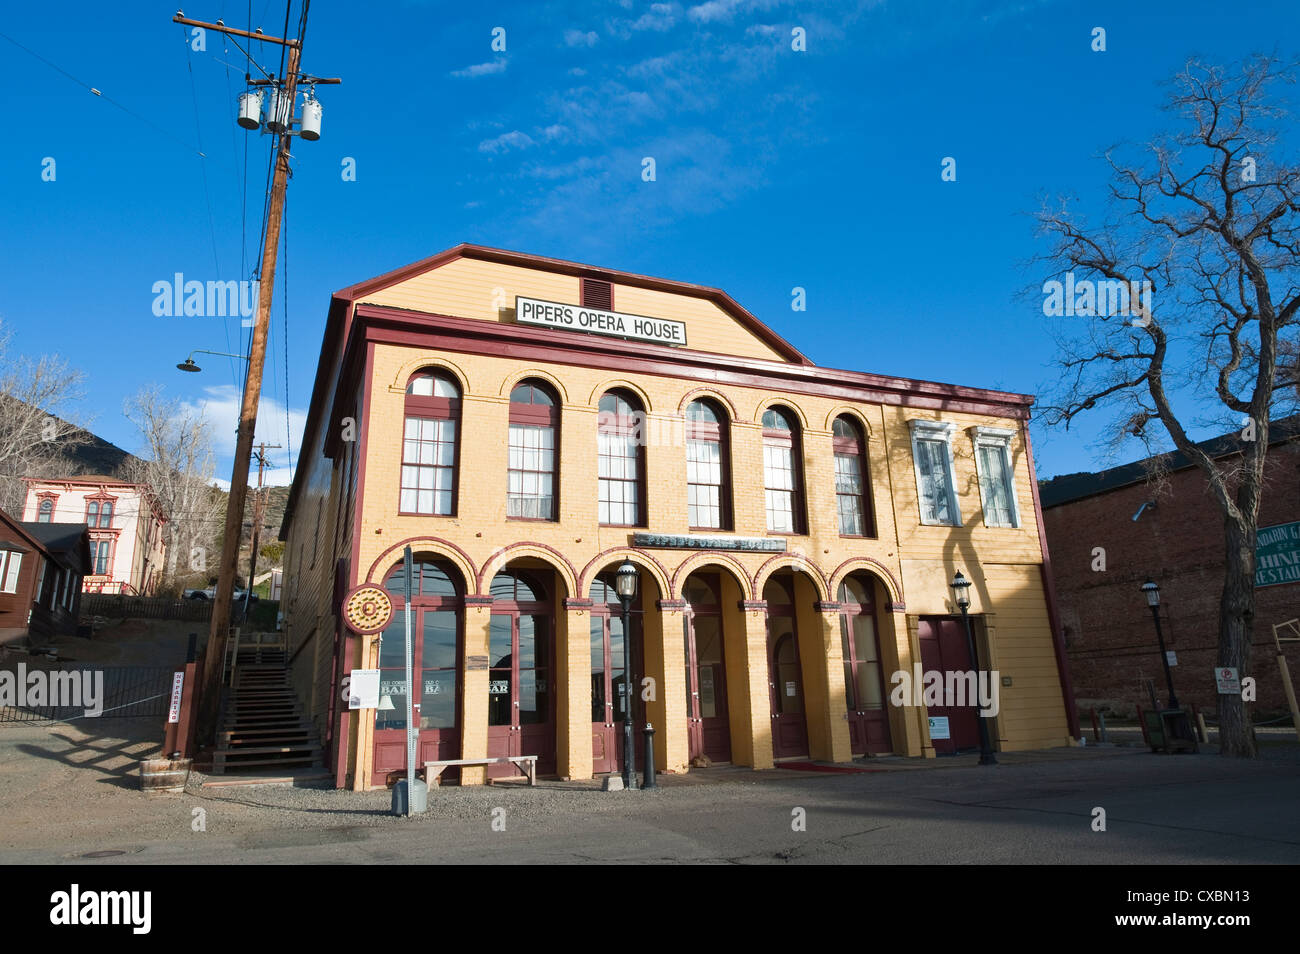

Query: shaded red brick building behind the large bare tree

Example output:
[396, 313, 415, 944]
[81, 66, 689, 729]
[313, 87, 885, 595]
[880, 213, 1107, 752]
[1041, 417, 1300, 723]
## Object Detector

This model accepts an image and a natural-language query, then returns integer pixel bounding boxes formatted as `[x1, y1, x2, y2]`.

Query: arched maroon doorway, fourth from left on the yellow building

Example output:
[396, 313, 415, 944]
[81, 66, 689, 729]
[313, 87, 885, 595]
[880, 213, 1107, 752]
[681, 571, 732, 762]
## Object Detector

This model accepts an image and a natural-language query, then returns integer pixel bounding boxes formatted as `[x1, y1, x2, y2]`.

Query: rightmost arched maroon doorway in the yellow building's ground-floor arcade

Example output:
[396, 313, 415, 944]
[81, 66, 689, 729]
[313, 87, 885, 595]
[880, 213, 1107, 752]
[839, 573, 893, 755]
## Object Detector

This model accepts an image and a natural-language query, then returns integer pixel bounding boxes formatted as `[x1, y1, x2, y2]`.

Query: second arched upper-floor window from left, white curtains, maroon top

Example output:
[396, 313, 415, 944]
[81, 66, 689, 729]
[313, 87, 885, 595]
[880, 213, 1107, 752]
[506, 381, 560, 520]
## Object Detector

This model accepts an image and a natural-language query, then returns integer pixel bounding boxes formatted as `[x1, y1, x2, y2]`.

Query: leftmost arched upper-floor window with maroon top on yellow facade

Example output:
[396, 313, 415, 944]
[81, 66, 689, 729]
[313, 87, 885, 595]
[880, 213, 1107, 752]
[400, 370, 460, 516]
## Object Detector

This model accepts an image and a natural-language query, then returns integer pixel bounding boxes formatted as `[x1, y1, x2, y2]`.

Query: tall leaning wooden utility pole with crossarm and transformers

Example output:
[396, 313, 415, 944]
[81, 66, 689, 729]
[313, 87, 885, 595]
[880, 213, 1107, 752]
[172, 0, 338, 745]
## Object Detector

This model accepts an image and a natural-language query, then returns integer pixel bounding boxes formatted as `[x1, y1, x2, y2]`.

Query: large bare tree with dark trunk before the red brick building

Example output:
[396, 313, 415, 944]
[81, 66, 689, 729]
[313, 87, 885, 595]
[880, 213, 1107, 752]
[1039, 57, 1300, 756]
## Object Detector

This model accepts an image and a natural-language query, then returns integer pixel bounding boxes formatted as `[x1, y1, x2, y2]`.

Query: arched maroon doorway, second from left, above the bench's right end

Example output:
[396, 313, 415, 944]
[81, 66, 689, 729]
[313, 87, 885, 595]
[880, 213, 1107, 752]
[488, 567, 555, 779]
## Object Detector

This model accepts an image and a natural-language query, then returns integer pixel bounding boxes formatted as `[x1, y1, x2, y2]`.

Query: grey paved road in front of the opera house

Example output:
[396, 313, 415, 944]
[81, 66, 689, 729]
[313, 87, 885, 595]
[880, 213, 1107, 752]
[0, 750, 1300, 864]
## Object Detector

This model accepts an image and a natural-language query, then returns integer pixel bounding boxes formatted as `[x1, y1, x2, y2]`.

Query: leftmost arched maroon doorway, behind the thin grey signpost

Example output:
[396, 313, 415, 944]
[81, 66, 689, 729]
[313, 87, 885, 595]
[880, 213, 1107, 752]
[372, 554, 464, 784]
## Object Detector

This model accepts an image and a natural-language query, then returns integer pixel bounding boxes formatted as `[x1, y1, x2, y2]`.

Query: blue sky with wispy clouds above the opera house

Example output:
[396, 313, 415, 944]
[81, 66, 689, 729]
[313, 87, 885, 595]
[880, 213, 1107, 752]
[0, 0, 1300, 482]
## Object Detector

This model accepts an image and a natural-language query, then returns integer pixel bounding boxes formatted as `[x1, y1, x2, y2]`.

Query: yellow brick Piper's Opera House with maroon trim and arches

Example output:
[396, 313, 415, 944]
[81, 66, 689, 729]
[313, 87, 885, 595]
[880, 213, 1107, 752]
[281, 246, 1078, 789]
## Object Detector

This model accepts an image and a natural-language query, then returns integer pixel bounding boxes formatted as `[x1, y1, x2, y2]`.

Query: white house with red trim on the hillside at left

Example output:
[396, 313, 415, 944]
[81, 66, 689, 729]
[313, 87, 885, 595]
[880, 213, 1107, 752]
[22, 474, 166, 597]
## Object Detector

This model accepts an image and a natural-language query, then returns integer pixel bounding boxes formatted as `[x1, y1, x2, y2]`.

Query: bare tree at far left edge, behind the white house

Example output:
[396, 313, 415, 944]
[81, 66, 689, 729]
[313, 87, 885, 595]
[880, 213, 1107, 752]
[0, 320, 85, 519]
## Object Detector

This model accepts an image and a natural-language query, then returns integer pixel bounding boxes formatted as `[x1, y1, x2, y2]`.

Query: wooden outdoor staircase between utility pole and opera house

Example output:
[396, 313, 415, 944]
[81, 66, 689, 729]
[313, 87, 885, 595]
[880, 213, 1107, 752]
[212, 633, 324, 775]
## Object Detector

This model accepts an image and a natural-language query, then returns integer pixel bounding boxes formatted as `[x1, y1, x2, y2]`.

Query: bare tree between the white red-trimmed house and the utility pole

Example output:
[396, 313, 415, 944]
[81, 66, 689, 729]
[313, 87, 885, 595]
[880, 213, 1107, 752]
[122, 386, 225, 589]
